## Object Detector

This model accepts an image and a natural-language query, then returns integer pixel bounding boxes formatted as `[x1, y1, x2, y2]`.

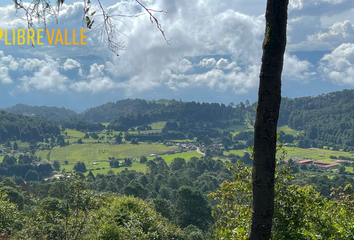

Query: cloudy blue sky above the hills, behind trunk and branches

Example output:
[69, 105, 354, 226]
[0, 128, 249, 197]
[0, 0, 354, 112]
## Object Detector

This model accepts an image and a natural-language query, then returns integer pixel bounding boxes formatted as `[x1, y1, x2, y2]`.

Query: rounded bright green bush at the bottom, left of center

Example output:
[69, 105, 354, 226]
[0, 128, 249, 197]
[97, 196, 183, 240]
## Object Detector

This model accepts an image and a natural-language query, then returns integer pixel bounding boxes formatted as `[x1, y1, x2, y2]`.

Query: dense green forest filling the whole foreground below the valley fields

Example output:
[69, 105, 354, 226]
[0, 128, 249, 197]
[0, 157, 354, 240]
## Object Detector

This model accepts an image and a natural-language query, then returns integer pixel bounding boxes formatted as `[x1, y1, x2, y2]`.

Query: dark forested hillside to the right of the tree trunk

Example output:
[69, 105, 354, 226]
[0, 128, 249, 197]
[279, 90, 354, 148]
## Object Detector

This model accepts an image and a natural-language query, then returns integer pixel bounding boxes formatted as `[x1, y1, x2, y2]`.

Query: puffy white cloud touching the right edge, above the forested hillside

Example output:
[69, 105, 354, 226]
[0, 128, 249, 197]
[319, 43, 354, 85]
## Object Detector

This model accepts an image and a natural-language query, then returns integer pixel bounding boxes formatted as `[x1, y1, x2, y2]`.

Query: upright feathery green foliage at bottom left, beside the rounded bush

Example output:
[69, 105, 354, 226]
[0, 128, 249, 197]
[14, 176, 102, 239]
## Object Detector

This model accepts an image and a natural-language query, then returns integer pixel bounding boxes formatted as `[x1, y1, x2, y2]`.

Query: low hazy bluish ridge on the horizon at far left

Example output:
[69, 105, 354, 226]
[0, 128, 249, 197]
[4, 104, 78, 120]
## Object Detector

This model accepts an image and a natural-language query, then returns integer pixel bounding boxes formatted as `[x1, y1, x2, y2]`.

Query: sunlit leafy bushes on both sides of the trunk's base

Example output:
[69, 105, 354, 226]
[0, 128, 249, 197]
[209, 143, 354, 240]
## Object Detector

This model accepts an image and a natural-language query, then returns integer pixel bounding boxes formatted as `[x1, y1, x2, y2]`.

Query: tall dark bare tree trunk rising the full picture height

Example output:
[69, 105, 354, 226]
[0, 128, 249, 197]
[248, 0, 289, 240]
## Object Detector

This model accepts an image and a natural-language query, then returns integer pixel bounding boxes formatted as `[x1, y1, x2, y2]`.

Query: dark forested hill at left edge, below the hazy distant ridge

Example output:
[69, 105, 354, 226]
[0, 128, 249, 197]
[0, 111, 60, 142]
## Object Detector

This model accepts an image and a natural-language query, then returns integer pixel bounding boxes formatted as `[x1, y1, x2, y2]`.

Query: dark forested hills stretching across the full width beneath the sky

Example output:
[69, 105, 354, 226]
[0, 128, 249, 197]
[4, 90, 354, 151]
